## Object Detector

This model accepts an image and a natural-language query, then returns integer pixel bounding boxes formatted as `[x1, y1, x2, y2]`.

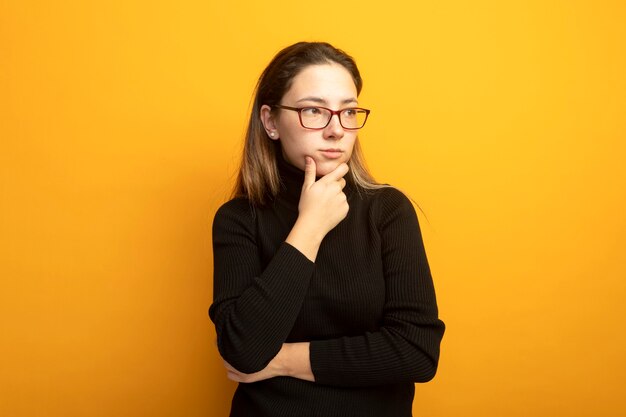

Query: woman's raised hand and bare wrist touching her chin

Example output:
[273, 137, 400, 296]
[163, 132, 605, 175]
[286, 156, 349, 261]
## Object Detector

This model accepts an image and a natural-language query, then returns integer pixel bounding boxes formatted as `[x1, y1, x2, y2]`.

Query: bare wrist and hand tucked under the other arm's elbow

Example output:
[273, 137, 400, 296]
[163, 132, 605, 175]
[224, 342, 315, 384]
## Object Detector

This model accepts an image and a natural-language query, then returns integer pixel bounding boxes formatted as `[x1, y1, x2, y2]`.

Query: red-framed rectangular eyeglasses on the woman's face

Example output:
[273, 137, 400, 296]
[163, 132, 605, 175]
[274, 104, 370, 130]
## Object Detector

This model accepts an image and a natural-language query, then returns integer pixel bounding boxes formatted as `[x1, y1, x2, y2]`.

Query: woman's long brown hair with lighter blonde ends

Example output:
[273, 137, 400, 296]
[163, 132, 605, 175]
[232, 42, 384, 206]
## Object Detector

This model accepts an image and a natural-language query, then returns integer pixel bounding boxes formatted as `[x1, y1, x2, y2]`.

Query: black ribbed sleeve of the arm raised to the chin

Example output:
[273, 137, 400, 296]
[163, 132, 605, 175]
[209, 200, 314, 373]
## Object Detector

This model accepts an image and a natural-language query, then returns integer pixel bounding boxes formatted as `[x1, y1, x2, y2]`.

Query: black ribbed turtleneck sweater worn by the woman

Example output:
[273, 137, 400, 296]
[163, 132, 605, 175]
[209, 160, 444, 417]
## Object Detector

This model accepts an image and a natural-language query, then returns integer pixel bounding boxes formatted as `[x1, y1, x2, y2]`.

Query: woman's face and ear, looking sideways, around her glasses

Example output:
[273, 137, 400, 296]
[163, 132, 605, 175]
[261, 63, 358, 176]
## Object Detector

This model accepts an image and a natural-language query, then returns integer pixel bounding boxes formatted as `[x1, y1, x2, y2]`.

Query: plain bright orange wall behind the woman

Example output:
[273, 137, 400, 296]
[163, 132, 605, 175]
[0, 0, 626, 417]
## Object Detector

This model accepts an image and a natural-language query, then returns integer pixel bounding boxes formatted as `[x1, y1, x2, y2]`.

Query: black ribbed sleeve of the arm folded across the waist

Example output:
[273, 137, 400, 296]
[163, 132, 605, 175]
[310, 188, 445, 387]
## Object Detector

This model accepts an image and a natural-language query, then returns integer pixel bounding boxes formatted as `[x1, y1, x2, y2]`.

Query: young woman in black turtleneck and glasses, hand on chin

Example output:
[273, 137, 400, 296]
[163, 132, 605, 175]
[209, 42, 444, 417]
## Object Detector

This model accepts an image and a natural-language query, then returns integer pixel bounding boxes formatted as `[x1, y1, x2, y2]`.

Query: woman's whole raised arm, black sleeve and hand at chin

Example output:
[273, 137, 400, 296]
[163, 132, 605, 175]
[209, 158, 348, 373]
